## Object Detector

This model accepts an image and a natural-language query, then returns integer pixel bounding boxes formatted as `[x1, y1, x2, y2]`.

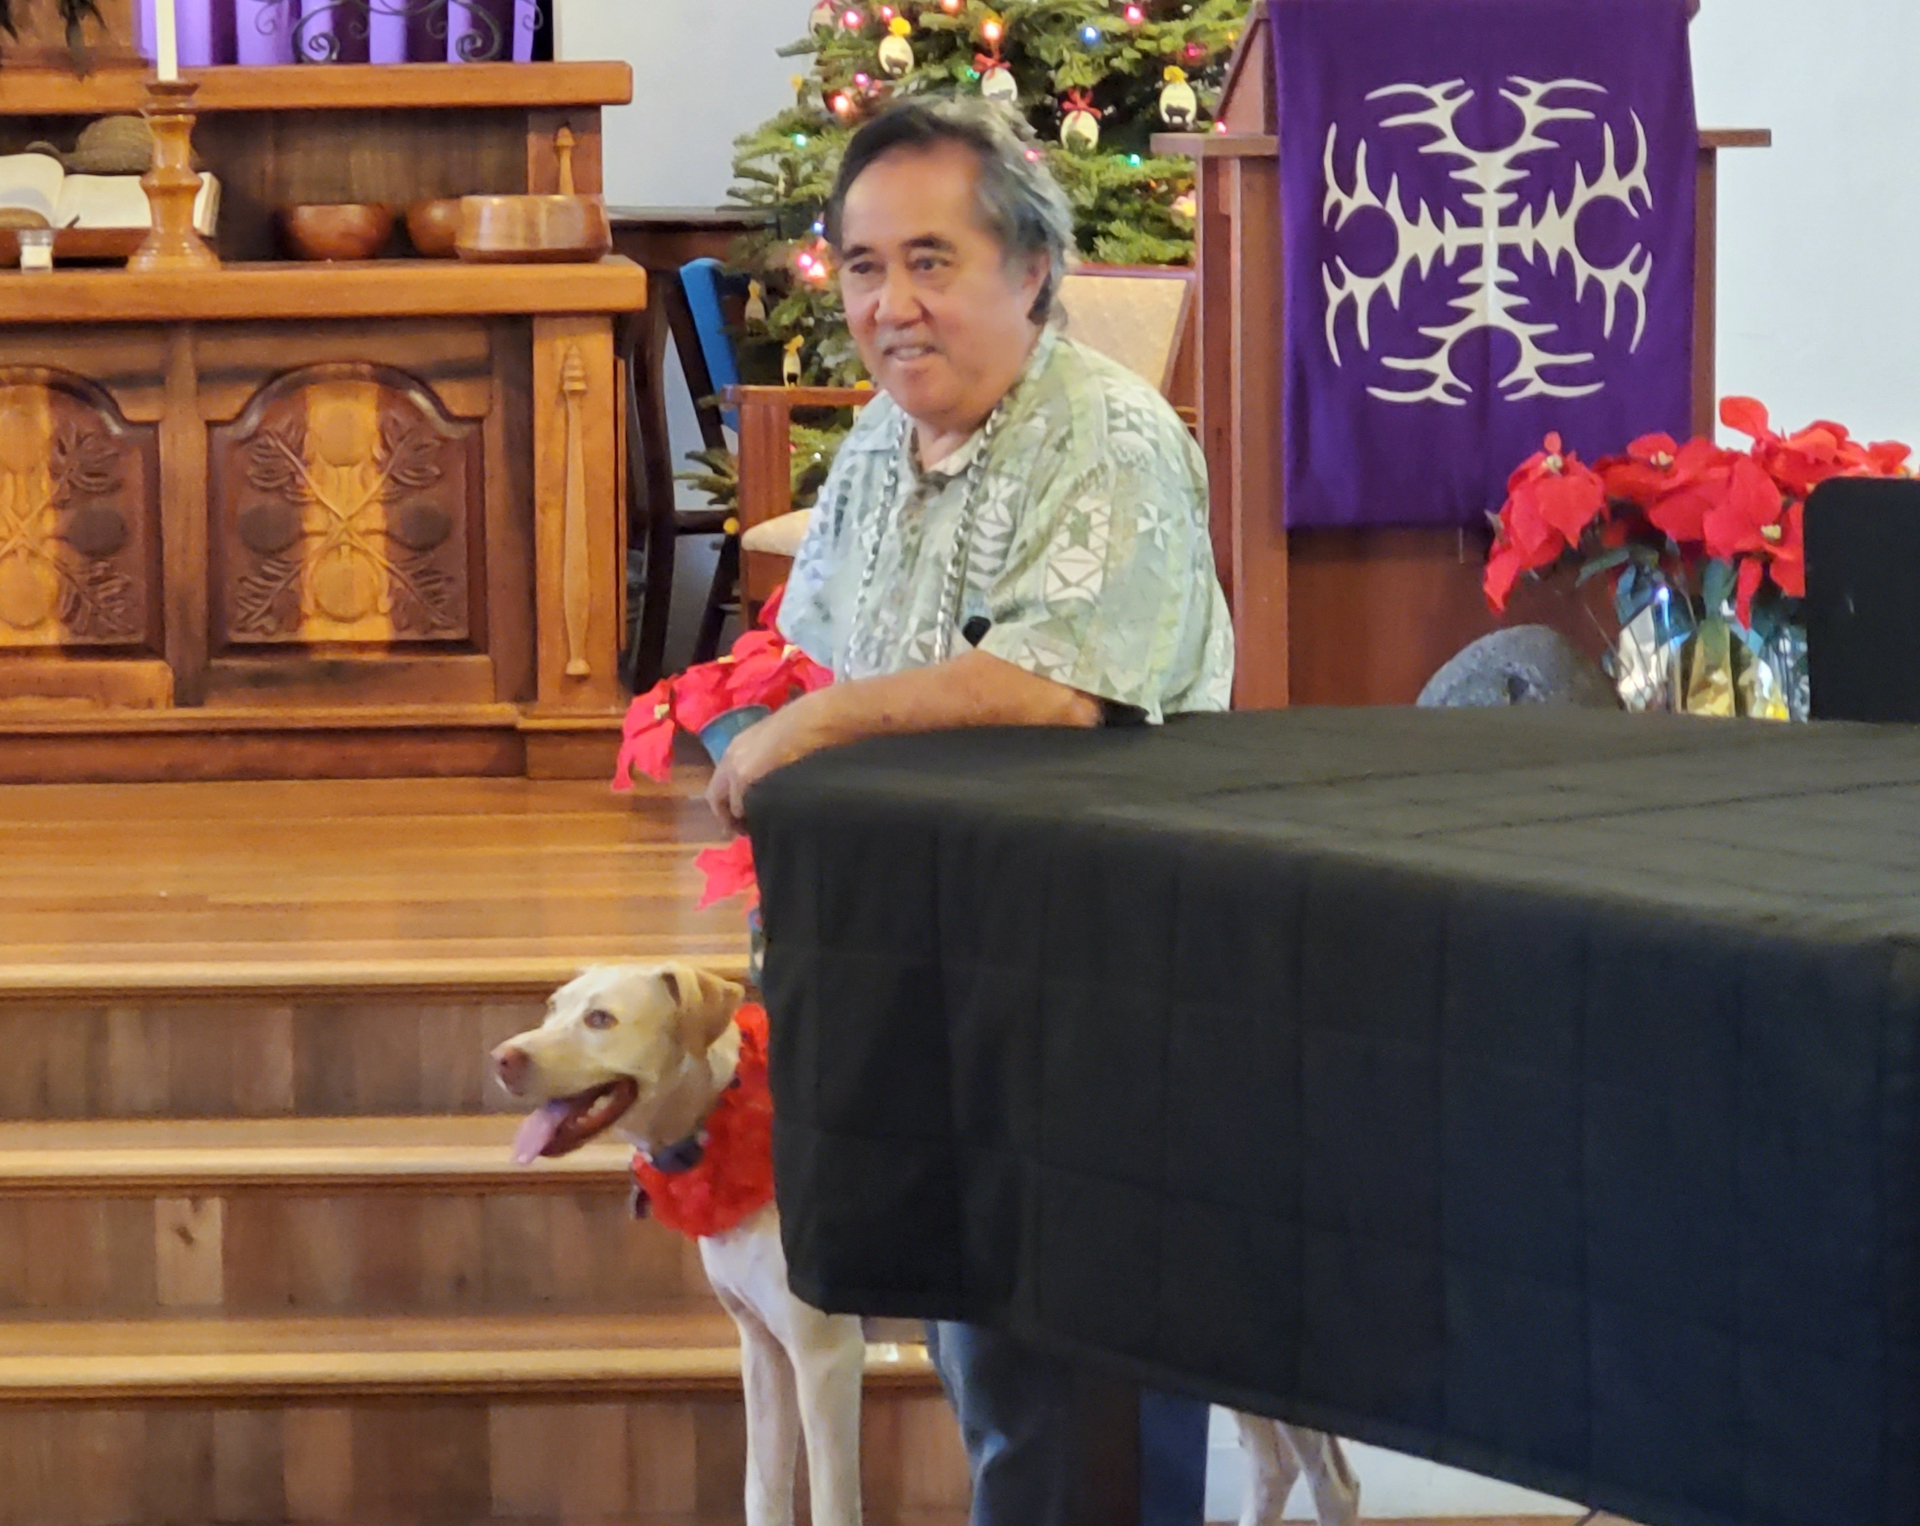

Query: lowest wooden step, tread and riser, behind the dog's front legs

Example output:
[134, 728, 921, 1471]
[0, 1313, 966, 1526]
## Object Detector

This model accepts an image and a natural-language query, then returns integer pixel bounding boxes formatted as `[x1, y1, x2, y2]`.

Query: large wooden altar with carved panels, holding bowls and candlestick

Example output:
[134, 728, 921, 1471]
[0, 63, 647, 781]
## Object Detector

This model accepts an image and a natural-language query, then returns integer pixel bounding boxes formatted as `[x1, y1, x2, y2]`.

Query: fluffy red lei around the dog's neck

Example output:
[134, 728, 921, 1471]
[634, 1002, 774, 1240]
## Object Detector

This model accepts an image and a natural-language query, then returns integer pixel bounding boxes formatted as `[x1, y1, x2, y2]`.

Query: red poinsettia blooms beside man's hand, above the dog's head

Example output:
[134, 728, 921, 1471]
[612, 587, 833, 979]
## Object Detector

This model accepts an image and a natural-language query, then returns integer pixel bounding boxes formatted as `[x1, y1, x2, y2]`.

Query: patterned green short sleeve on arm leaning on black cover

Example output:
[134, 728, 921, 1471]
[979, 441, 1215, 722]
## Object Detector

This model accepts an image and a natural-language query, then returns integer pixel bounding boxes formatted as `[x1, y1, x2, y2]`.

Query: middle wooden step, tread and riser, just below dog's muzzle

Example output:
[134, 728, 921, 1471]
[0, 1117, 710, 1317]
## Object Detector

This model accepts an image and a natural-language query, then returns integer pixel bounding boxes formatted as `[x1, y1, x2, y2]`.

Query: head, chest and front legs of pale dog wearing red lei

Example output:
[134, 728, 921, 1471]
[493, 964, 866, 1526]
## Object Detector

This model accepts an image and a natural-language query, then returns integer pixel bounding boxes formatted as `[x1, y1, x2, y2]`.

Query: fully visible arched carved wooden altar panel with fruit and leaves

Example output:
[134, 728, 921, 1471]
[207, 372, 484, 651]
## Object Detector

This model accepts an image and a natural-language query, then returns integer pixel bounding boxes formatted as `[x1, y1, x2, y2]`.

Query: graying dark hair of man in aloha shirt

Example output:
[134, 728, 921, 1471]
[826, 98, 1073, 322]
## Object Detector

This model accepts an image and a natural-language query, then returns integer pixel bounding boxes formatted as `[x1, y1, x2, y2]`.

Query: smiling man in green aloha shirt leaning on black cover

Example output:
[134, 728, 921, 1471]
[707, 102, 1233, 1526]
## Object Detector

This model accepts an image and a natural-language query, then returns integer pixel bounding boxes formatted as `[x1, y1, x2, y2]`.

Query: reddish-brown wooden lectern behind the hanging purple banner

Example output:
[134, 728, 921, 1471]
[1154, 6, 1772, 710]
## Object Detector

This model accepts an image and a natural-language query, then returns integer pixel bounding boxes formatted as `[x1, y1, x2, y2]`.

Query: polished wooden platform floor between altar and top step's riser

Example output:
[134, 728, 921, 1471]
[0, 775, 745, 996]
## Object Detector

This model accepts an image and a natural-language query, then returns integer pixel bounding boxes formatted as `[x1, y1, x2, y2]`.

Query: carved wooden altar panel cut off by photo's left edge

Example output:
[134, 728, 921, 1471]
[0, 367, 159, 655]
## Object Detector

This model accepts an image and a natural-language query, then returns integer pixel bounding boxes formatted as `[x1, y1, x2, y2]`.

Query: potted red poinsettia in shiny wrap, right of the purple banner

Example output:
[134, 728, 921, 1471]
[1484, 397, 1912, 720]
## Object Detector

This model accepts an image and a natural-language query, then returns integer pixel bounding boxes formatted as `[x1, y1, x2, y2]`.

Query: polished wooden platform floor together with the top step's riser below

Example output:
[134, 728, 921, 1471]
[0, 779, 747, 1119]
